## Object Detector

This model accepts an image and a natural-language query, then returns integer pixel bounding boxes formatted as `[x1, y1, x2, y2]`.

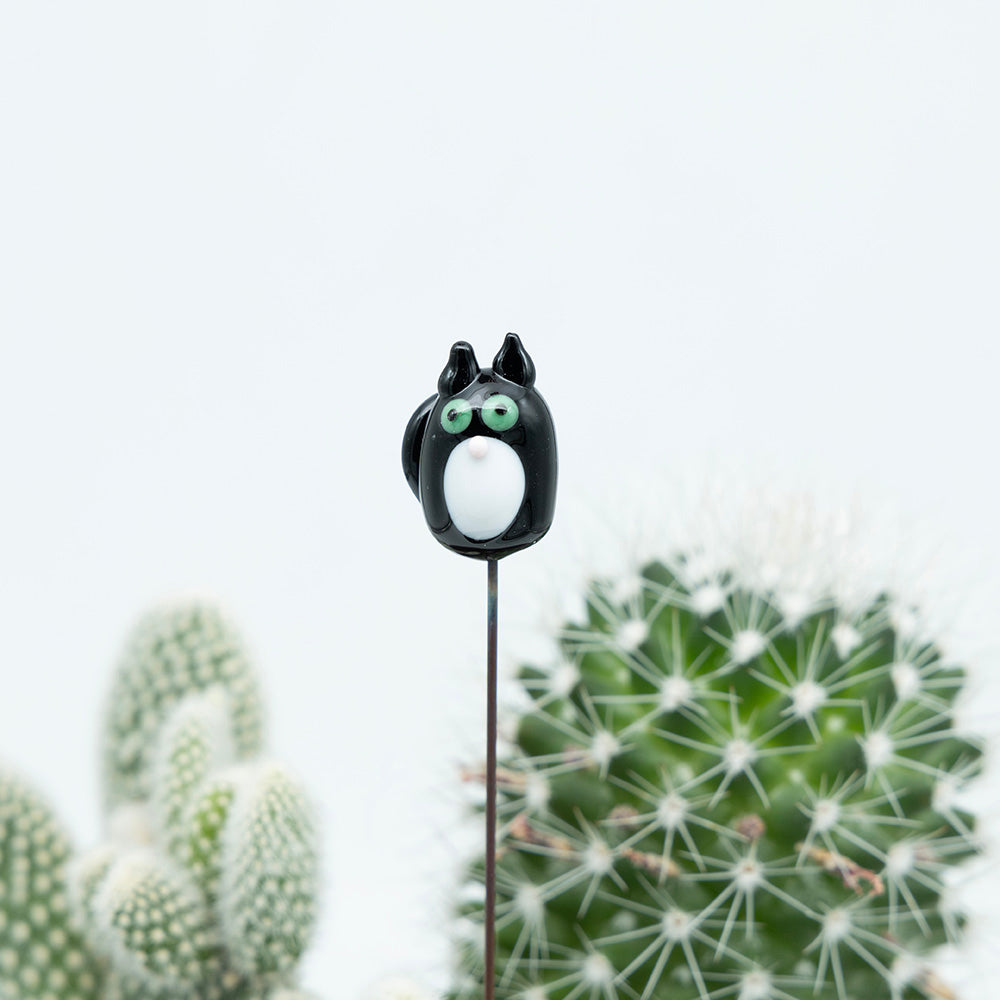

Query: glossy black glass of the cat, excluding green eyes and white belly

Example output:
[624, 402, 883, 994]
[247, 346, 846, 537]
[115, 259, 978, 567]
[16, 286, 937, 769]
[403, 333, 556, 559]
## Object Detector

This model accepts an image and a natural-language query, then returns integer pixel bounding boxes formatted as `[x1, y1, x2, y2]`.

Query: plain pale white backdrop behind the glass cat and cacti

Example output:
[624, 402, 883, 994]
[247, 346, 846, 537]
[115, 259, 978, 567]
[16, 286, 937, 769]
[0, 0, 1000, 1000]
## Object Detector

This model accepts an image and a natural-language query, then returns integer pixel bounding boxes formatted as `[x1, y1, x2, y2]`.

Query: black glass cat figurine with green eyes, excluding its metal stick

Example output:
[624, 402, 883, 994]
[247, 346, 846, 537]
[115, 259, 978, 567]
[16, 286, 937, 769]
[403, 333, 556, 559]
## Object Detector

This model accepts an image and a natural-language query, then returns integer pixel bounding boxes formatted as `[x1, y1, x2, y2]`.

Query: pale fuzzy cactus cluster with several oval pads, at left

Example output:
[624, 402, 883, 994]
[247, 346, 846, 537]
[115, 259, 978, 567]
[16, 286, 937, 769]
[0, 603, 318, 1000]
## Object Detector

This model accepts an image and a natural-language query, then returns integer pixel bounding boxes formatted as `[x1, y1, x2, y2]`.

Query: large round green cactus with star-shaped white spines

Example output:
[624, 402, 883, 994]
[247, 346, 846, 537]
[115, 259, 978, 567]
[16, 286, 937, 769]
[453, 559, 981, 1000]
